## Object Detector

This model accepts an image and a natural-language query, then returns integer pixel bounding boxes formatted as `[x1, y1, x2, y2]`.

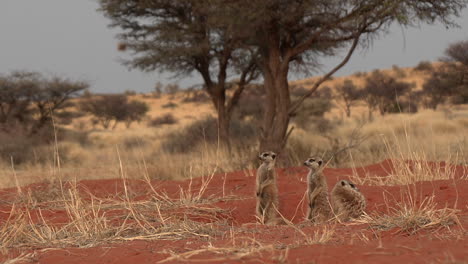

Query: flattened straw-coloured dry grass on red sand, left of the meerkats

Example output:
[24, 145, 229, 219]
[0, 170, 228, 250]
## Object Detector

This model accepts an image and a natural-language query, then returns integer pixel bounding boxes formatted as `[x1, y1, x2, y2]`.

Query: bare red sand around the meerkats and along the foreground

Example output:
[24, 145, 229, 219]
[0, 161, 468, 264]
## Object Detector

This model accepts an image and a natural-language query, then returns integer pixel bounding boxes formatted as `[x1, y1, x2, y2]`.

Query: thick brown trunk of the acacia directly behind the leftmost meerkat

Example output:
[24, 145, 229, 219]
[260, 42, 291, 154]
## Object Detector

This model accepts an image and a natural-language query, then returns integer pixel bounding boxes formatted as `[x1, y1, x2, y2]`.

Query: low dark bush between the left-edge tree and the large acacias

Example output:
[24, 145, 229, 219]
[80, 94, 149, 129]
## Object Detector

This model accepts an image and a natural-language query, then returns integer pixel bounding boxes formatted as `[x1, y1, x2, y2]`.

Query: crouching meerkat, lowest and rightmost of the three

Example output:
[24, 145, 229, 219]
[330, 180, 366, 222]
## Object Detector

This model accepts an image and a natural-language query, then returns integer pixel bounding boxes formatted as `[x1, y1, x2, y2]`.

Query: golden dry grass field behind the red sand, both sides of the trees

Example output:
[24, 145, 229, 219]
[0, 64, 468, 188]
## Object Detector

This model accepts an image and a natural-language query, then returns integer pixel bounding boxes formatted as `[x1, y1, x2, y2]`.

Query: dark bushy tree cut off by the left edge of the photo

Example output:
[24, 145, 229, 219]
[0, 71, 89, 134]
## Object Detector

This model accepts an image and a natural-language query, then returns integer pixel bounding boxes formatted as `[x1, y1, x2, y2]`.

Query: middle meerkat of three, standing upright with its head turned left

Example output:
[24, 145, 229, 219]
[304, 157, 332, 223]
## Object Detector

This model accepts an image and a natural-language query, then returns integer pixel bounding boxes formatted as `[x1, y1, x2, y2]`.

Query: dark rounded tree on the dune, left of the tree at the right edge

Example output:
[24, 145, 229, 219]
[362, 70, 414, 119]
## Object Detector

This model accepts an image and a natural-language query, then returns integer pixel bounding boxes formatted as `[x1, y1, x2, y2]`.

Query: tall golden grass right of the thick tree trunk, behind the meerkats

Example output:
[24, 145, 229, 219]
[287, 110, 468, 168]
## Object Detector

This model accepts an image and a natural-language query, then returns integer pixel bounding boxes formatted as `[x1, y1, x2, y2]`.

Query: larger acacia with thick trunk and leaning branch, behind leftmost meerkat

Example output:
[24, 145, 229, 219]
[227, 0, 468, 152]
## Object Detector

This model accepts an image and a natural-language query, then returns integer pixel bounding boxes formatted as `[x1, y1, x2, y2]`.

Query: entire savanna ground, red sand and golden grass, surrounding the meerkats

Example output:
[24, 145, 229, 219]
[0, 65, 468, 264]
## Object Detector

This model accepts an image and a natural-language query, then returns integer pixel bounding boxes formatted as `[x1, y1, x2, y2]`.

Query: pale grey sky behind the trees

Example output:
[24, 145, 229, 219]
[0, 0, 468, 93]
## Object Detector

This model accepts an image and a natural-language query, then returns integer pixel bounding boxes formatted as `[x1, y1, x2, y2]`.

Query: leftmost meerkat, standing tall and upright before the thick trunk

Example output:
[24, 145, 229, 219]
[256, 151, 280, 225]
